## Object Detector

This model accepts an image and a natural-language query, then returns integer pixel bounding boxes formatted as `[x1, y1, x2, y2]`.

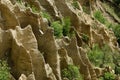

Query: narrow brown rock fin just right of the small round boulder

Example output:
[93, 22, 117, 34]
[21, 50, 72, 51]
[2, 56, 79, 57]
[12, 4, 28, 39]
[66, 39, 91, 80]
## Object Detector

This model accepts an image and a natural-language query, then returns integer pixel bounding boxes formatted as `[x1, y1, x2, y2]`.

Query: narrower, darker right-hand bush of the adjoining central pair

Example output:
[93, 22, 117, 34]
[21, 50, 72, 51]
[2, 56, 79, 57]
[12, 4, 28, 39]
[62, 17, 71, 36]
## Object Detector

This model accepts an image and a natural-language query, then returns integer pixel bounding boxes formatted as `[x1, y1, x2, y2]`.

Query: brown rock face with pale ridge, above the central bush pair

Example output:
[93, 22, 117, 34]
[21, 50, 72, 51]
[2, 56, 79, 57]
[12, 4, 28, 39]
[55, 0, 80, 29]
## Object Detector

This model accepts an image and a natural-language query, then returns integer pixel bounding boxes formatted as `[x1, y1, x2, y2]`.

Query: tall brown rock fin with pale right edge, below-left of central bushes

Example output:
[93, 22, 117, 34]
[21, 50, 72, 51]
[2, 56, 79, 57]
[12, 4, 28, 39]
[38, 29, 61, 80]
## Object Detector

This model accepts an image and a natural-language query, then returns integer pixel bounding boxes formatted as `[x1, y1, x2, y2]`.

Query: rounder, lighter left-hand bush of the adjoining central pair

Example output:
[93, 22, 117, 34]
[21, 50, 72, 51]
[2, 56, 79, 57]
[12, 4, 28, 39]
[51, 21, 63, 38]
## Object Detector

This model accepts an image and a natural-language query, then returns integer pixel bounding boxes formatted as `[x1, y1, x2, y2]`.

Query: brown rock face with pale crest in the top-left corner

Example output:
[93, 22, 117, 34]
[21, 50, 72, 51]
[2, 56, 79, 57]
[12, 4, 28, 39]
[0, 0, 18, 29]
